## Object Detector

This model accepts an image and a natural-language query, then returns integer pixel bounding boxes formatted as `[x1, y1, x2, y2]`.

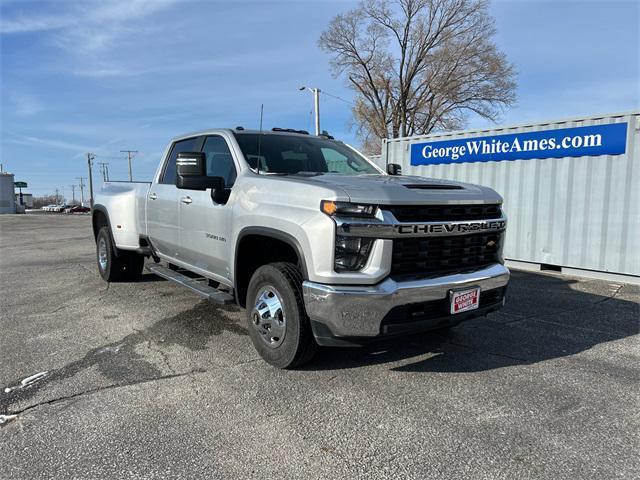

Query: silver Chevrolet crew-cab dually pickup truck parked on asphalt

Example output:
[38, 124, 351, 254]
[93, 127, 509, 368]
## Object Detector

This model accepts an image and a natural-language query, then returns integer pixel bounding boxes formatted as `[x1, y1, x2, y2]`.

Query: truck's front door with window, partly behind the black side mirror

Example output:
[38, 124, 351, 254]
[180, 135, 237, 280]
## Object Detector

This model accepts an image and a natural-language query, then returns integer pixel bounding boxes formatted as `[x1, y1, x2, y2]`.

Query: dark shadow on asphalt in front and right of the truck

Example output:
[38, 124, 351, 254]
[306, 272, 640, 372]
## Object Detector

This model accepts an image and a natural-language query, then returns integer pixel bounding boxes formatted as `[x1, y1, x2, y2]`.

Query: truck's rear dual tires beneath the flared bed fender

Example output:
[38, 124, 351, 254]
[96, 227, 144, 282]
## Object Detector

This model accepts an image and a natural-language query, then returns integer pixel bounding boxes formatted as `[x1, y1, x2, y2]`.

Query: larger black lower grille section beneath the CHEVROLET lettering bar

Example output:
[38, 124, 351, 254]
[391, 232, 502, 278]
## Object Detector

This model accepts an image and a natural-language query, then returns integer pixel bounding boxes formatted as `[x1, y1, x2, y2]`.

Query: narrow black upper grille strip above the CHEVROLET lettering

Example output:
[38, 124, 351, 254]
[388, 204, 502, 222]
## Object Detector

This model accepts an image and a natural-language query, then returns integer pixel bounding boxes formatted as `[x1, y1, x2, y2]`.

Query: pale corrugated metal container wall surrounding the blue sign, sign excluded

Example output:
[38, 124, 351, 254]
[376, 112, 640, 276]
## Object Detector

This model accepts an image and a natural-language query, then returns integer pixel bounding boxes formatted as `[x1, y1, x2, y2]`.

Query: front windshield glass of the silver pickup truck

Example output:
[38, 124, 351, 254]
[236, 133, 380, 175]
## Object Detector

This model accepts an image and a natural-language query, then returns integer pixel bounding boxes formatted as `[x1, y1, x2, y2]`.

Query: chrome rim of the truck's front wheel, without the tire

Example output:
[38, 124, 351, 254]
[251, 285, 287, 348]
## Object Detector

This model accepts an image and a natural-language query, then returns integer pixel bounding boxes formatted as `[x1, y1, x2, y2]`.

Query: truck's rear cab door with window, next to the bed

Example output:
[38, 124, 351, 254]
[147, 136, 204, 259]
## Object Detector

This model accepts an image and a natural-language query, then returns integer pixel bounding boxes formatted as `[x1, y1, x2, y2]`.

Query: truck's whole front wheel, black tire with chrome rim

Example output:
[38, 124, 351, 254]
[247, 262, 318, 369]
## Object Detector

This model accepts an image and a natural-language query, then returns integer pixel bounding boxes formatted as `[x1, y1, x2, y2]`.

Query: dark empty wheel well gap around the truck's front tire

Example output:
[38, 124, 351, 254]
[235, 234, 303, 307]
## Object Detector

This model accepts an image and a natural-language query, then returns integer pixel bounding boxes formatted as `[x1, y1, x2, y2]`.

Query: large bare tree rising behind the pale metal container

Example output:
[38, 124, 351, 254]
[319, 0, 516, 150]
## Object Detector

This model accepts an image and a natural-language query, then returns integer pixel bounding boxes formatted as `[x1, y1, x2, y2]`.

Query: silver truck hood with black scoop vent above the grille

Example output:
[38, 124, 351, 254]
[287, 174, 502, 205]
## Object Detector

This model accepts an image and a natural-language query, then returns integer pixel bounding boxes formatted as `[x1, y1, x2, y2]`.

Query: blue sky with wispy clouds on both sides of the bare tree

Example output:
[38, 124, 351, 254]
[0, 0, 640, 197]
